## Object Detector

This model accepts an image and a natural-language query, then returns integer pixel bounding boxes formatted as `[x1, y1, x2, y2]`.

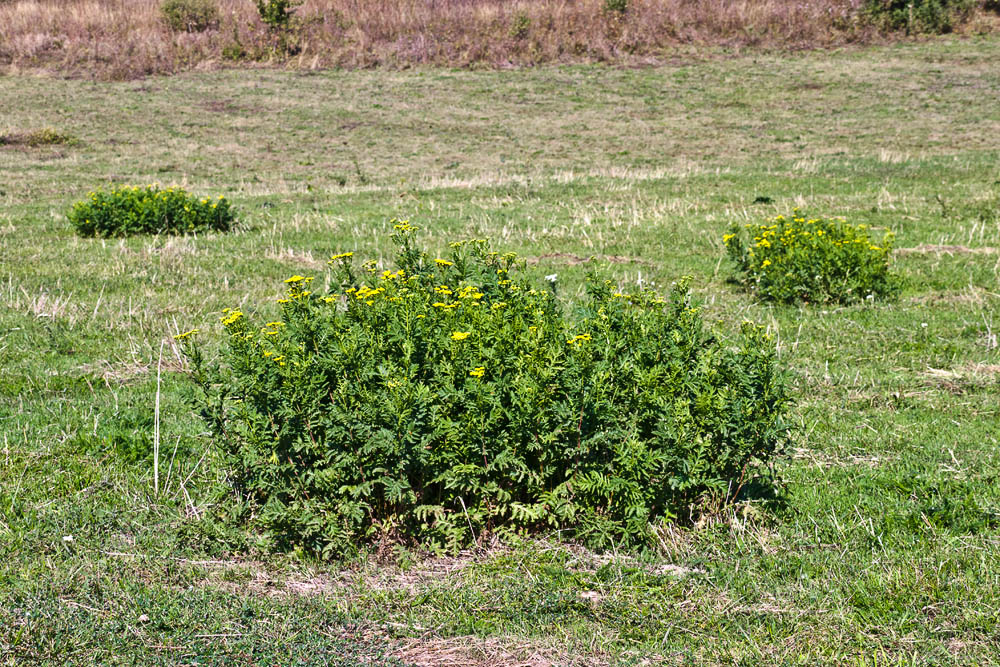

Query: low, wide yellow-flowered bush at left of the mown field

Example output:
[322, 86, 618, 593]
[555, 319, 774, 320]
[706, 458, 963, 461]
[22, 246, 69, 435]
[68, 185, 234, 237]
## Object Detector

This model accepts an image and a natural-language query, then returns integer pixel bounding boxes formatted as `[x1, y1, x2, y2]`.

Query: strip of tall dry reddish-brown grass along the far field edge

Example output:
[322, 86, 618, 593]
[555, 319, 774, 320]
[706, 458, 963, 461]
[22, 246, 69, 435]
[0, 0, 981, 79]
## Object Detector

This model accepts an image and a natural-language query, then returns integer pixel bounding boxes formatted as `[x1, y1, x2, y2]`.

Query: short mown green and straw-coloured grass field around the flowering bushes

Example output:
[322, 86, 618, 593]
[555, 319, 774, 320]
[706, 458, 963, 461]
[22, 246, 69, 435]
[0, 37, 1000, 665]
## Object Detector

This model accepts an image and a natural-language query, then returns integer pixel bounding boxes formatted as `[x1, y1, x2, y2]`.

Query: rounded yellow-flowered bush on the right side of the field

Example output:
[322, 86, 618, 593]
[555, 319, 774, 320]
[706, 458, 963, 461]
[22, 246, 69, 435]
[722, 209, 899, 303]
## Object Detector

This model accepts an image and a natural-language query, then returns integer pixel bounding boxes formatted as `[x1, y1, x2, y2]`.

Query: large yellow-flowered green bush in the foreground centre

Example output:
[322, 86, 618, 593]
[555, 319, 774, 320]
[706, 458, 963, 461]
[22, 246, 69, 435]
[179, 223, 788, 555]
